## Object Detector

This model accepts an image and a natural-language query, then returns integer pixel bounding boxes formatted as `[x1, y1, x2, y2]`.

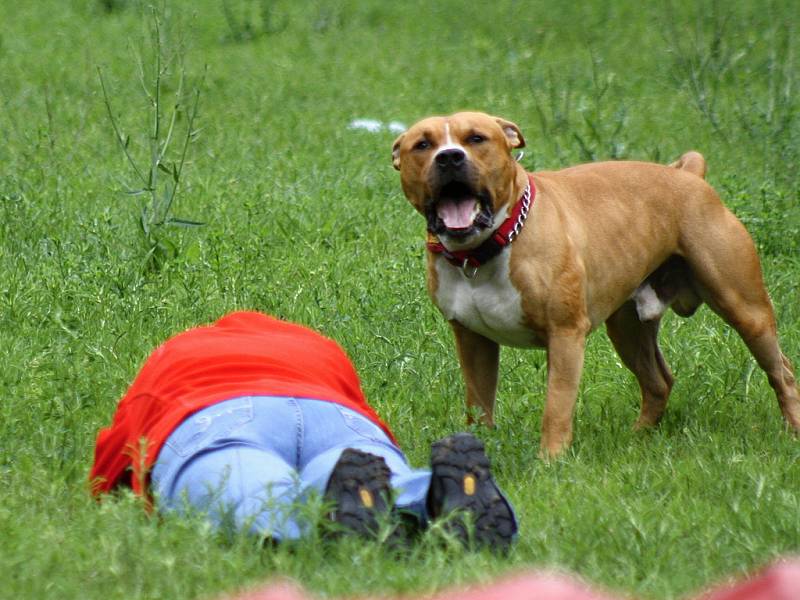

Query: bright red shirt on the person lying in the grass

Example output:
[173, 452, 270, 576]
[89, 312, 395, 495]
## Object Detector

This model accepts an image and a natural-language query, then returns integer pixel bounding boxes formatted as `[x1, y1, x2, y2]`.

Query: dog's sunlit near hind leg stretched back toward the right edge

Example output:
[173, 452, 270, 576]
[685, 210, 800, 431]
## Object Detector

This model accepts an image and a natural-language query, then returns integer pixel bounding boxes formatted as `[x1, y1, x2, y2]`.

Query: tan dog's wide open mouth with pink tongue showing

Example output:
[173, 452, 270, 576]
[428, 181, 492, 237]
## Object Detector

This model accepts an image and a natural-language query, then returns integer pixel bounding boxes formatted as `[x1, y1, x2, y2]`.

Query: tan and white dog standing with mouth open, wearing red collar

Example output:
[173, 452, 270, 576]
[392, 112, 800, 455]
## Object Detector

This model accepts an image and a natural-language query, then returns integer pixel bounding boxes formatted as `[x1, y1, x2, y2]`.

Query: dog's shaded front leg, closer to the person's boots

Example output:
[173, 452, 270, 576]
[450, 321, 500, 426]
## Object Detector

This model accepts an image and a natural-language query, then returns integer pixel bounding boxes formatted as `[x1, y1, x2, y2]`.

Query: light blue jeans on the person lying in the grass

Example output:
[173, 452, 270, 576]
[151, 396, 430, 540]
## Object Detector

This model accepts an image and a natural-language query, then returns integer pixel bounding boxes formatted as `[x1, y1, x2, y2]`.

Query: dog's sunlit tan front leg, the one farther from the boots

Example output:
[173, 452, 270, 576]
[540, 331, 586, 457]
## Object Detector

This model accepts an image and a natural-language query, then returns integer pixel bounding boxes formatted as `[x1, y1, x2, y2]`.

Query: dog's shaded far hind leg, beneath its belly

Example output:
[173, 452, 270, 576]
[606, 301, 673, 429]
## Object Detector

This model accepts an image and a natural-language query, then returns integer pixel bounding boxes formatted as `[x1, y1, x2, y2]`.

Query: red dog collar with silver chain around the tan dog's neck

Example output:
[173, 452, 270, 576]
[427, 175, 536, 279]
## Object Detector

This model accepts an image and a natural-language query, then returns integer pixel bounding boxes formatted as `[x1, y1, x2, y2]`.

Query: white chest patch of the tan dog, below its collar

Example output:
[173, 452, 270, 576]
[436, 251, 534, 347]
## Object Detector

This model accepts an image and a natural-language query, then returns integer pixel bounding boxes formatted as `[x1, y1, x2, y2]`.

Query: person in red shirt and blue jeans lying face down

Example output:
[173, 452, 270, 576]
[89, 312, 517, 550]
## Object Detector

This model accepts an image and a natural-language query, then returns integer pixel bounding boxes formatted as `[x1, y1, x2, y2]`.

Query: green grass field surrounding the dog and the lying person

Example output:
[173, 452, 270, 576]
[0, 0, 800, 599]
